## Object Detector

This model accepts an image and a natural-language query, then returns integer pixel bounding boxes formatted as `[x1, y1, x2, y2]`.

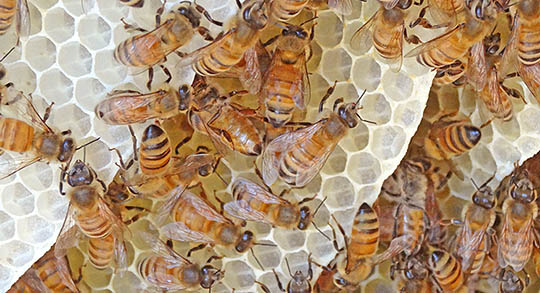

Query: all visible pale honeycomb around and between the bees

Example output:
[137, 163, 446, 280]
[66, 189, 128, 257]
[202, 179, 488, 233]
[0, 0, 540, 292]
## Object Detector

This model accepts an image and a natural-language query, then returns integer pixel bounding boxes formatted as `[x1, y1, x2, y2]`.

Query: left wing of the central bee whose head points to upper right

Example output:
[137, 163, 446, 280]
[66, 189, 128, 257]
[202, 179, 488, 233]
[262, 119, 326, 186]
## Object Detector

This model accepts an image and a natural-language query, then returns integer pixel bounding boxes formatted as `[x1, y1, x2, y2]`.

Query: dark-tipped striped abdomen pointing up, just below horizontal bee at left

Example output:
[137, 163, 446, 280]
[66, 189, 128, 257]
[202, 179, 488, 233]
[139, 124, 172, 176]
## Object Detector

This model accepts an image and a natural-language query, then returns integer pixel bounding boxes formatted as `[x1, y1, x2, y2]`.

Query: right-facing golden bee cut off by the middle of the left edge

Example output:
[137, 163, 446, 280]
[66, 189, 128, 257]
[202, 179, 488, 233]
[0, 94, 76, 179]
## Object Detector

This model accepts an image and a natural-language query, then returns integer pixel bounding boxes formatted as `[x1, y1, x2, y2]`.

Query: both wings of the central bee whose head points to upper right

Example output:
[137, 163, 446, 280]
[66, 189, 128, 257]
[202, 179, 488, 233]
[262, 119, 337, 187]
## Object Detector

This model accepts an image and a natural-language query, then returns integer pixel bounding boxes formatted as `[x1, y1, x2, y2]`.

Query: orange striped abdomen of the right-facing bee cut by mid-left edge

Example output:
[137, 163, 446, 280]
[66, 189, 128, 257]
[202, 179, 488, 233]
[0, 117, 34, 153]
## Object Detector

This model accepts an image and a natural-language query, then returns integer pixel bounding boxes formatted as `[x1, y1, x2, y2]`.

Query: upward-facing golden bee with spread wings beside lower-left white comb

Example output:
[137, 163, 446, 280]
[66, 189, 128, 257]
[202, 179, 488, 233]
[55, 160, 129, 269]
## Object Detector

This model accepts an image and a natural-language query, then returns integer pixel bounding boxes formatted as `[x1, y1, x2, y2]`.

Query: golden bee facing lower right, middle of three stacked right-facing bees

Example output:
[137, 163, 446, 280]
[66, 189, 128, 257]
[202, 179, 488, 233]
[158, 187, 255, 256]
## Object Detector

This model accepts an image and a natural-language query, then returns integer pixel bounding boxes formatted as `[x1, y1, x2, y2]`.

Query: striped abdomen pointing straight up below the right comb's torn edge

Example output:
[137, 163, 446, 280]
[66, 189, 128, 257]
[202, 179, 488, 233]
[347, 203, 379, 265]
